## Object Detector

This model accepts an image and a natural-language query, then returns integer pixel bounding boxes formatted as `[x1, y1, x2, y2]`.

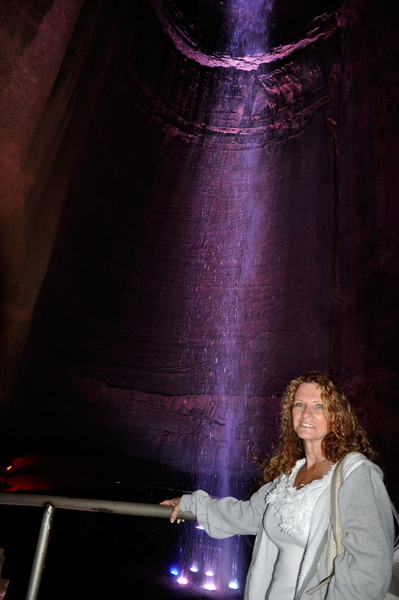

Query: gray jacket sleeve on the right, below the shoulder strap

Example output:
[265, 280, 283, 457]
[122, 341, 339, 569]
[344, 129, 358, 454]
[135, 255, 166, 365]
[326, 464, 394, 600]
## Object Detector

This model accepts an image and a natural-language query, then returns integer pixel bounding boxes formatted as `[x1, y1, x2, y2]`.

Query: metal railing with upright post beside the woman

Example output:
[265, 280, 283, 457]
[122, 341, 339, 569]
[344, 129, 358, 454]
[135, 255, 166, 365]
[0, 494, 197, 600]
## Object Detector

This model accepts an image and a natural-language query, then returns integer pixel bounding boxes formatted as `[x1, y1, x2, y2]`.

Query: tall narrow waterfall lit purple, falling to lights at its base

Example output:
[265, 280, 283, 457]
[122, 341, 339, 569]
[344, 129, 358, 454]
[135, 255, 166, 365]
[171, 0, 272, 597]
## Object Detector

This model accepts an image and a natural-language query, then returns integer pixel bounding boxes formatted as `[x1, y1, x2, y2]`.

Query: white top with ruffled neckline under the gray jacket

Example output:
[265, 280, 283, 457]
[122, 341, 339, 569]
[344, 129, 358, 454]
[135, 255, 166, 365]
[263, 459, 334, 600]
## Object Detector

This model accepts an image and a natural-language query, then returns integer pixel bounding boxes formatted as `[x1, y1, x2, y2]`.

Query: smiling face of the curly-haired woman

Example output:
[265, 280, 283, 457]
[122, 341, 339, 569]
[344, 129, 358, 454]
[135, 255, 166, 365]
[292, 383, 329, 443]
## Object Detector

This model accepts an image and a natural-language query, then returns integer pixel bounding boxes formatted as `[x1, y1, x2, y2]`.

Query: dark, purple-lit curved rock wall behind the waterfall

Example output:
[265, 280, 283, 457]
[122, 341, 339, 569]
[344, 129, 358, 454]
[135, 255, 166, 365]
[0, 0, 399, 488]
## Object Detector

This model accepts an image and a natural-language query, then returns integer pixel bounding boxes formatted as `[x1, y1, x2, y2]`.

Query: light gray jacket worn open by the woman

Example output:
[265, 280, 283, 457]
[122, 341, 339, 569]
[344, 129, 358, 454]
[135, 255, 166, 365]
[180, 453, 394, 600]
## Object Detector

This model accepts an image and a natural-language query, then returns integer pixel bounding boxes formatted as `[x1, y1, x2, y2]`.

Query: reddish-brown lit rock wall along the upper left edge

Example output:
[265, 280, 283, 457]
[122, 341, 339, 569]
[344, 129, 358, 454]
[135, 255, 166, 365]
[0, 1, 82, 400]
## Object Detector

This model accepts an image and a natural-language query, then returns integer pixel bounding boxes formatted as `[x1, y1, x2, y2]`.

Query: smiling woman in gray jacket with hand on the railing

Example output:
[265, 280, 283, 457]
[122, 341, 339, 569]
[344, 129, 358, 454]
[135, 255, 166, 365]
[161, 371, 394, 600]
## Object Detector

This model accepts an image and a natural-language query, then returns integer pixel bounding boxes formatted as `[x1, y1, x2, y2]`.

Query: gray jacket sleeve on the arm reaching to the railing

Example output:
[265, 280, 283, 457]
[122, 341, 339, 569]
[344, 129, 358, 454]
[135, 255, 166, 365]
[180, 484, 270, 539]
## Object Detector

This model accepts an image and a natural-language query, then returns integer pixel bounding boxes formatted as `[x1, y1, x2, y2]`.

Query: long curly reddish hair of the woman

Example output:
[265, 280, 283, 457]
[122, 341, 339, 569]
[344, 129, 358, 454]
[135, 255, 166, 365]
[262, 371, 374, 483]
